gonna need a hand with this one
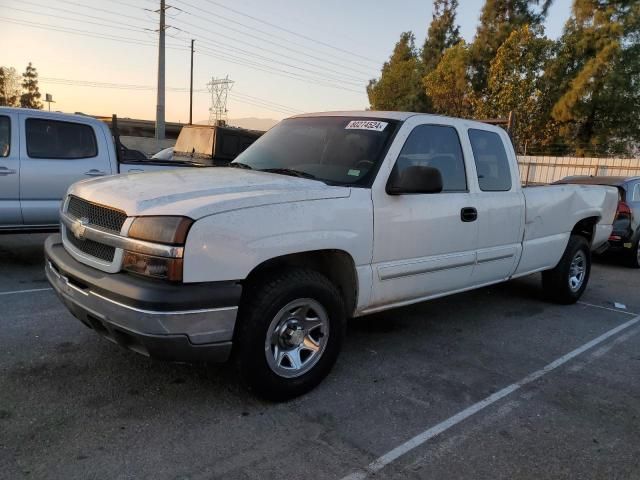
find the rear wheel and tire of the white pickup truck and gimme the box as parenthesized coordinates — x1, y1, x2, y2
(542, 235, 591, 305)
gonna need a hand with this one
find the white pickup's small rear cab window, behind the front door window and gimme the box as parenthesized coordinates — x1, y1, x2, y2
(469, 129, 511, 192)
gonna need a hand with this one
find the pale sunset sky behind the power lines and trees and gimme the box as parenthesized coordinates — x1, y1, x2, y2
(0, 0, 571, 122)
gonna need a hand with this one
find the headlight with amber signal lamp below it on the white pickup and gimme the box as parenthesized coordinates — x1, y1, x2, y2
(122, 217, 193, 282)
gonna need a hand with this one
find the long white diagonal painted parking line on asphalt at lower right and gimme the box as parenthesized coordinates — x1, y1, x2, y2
(342, 316, 640, 480)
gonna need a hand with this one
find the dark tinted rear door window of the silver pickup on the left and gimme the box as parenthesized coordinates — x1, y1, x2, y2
(26, 118, 98, 160)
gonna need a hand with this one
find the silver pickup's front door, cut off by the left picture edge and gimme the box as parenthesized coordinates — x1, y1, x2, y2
(0, 113, 22, 228)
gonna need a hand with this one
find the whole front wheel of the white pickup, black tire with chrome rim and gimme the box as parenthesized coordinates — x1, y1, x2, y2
(234, 269, 346, 401)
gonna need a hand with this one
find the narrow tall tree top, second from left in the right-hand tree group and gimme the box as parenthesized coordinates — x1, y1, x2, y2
(420, 0, 460, 75)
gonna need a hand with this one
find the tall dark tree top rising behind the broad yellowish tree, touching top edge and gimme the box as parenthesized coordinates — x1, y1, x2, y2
(470, 0, 553, 94)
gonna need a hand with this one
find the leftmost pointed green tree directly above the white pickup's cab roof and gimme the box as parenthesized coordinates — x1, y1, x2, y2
(367, 32, 427, 112)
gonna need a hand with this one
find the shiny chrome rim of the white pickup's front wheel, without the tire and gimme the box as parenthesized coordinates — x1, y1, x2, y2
(264, 298, 329, 378)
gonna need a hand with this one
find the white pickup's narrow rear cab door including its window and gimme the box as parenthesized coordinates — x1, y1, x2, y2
(467, 128, 525, 285)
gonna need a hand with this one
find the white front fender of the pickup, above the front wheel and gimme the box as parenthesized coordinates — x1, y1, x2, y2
(184, 189, 373, 283)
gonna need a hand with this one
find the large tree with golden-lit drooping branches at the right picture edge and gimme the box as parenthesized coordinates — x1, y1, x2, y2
(549, 0, 640, 155)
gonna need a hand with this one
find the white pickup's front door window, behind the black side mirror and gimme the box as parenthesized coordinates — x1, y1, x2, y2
(395, 125, 467, 192)
